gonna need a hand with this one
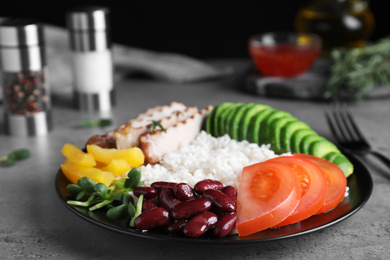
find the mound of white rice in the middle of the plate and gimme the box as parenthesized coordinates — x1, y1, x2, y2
(141, 131, 286, 188)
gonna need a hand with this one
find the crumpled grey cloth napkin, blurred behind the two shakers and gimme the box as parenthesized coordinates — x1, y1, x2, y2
(44, 25, 232, 95)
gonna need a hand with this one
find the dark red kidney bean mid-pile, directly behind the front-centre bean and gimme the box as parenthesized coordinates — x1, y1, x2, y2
(170, 198, 211, 219)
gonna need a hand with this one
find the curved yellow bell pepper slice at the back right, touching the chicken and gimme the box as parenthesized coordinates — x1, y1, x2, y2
(87, 144, 145, 168)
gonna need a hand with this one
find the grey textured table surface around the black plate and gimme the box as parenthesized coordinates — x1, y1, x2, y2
(0, 60, 390, 259)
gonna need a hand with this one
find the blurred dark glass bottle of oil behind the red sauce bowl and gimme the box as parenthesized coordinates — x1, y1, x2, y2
(295, 0, 375, 57)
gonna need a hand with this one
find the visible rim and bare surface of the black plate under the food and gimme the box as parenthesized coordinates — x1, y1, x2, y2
(55, 151, 373, 245)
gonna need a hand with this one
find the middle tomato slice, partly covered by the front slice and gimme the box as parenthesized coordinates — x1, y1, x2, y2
(271, 156, 328, 227)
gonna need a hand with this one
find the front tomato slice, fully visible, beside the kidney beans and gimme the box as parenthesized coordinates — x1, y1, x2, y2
(236, 161, 301, 236)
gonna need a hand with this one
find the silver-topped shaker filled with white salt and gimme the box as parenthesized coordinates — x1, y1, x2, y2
(67, 6, 115, 112)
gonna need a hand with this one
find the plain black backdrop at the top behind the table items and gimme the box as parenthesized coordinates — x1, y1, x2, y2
(0, 0, 390, 58)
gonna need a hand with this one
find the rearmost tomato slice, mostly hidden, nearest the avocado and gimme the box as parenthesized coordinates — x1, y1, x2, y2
(293, 154, 347, 214)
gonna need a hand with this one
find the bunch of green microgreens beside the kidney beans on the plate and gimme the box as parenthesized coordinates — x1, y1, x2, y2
(66, 168, 143, 222)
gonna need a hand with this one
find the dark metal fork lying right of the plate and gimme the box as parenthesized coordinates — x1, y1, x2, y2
(326, 104, 390, 168)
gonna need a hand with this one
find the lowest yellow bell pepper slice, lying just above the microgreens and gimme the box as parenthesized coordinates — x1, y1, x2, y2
(61, 159, 115, 187)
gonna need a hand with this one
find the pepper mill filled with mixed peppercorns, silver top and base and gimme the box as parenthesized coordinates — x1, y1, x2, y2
(0, 18, 52, 136)
